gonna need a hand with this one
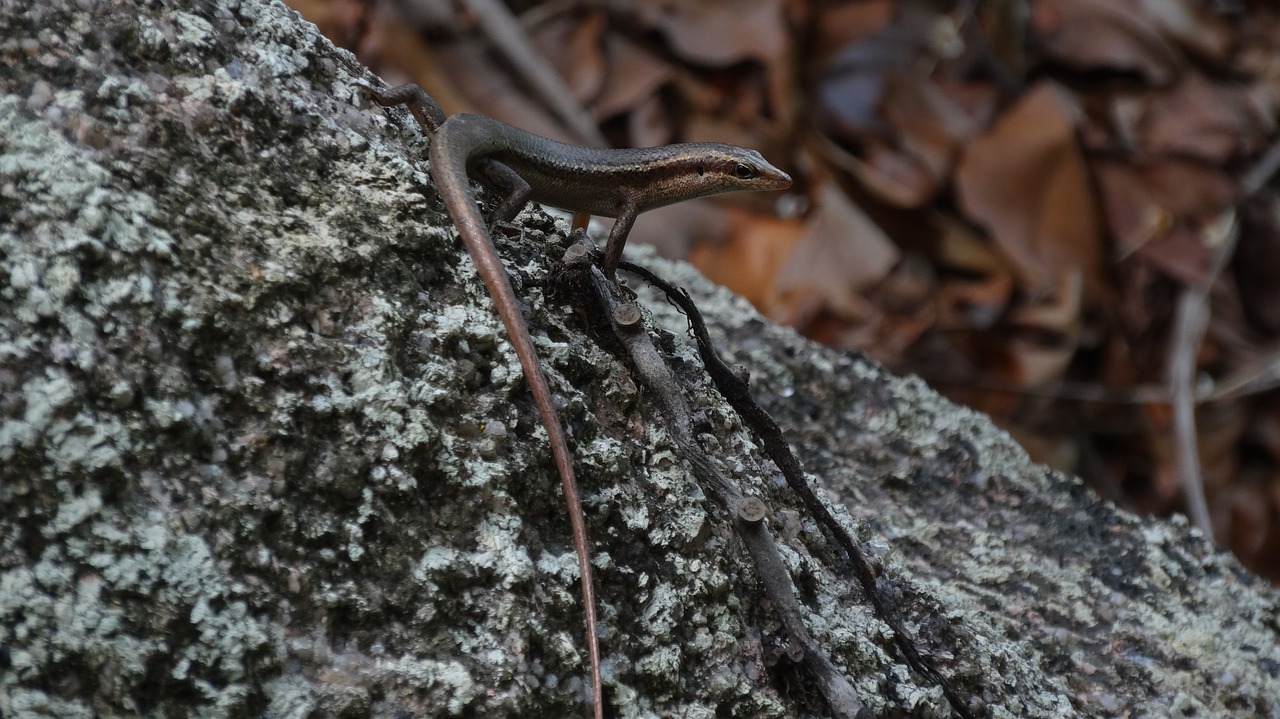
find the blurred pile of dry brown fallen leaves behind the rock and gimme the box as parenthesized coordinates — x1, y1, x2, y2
(291, 0, 1280, 580)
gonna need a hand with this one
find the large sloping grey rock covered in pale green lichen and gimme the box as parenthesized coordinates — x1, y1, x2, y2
(0, 0, 1280, 718)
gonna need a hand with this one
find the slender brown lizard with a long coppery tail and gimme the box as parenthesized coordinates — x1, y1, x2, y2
(358, 83, 791, 719)
